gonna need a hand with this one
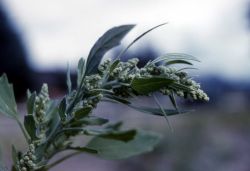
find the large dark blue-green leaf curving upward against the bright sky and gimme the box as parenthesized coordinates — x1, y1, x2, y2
(86, 25, 135, 75)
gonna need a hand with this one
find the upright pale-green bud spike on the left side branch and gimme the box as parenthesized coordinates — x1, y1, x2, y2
(35, 84, 49, 123)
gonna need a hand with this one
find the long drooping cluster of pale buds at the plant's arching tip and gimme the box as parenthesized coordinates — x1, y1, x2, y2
(97, 58, 209, 101)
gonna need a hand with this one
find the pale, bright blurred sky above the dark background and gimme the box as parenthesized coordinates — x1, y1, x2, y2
(1, 0, 250, 79)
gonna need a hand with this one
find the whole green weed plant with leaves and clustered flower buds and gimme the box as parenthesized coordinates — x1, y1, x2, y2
(0, 25, 209, 171)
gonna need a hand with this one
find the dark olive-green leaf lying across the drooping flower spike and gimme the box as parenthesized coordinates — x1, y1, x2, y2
(131, 77, 174, 95)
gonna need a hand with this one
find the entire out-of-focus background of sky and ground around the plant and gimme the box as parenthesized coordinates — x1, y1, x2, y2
(0, 0, 250, 171)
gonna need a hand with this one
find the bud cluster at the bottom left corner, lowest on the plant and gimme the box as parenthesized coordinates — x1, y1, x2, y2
(17, 144, 36, 171)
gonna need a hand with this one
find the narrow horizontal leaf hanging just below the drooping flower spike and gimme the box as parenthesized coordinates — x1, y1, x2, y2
(129, 105, 191, 116)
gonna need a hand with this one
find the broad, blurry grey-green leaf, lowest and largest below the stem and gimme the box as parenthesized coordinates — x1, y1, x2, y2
(86, 131, 160, 160)
